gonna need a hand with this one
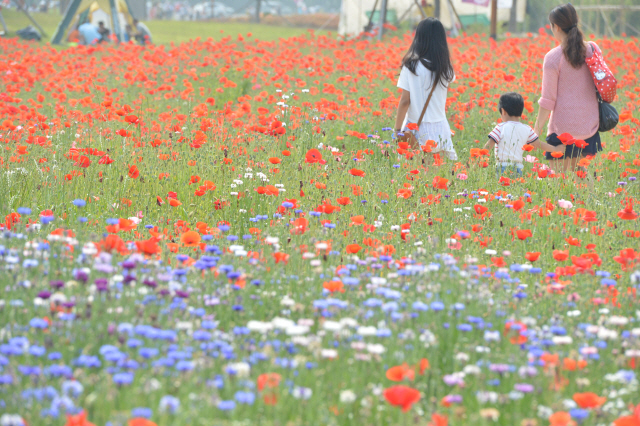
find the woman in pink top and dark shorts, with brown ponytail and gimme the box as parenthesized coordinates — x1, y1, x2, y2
(534, 3, 602, 171)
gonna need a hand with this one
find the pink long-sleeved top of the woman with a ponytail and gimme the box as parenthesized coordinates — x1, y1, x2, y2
(538, 43, 600, 139)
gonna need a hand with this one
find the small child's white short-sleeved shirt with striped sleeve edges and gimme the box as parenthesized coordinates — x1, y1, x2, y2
(489, 121, 538, 165)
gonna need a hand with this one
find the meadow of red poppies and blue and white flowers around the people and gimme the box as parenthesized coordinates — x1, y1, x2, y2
(0, 32, 640, 426)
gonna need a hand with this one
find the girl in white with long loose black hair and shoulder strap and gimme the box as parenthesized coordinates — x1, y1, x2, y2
(394, 18, 458, 160)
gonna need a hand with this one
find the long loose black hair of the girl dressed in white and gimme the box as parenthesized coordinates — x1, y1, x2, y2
(402, 18, 454, 86)
